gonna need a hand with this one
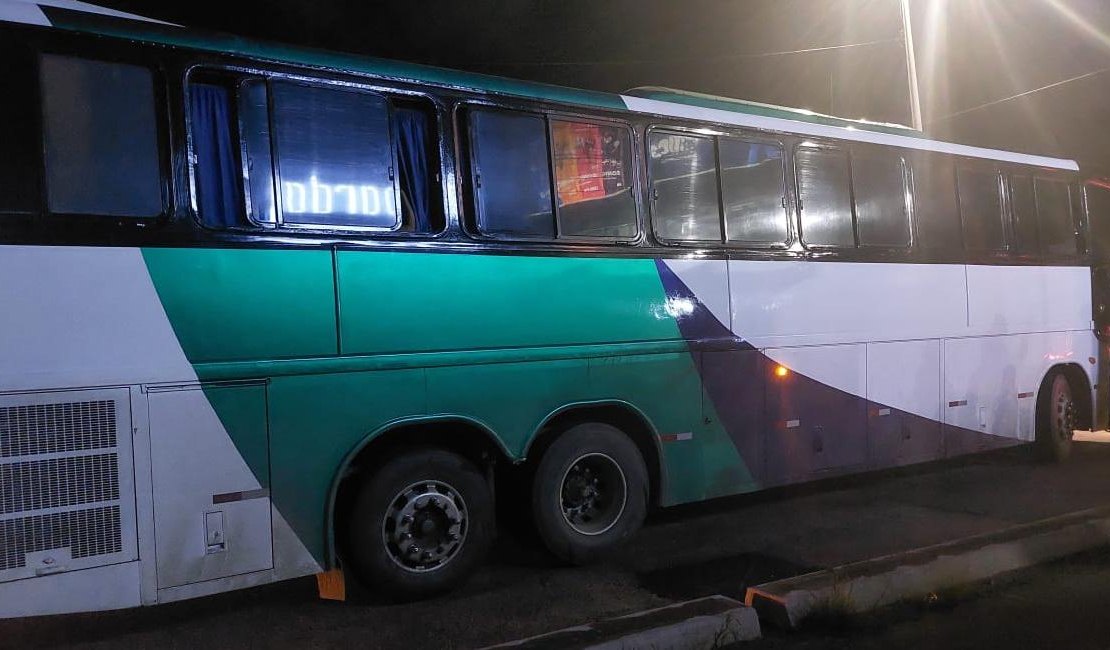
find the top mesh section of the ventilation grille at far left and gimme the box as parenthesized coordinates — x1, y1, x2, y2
(0, 399, 115, 458)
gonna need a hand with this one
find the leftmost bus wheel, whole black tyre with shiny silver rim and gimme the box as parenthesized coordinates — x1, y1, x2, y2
(346, 449, 493, 600)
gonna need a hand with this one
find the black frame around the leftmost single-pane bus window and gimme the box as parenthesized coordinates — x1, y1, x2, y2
(38, 49, 173, 224)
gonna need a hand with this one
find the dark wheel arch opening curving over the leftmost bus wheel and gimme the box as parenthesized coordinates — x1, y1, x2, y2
(324, 415, 517, 568)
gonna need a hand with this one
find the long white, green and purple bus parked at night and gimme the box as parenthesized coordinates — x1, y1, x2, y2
(0, 0, 1110, 617)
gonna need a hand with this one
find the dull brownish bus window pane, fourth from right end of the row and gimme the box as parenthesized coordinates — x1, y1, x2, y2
(911, 156, 963, 251)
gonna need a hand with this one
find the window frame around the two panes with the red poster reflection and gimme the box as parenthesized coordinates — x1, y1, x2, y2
(466, 100, 644, 246)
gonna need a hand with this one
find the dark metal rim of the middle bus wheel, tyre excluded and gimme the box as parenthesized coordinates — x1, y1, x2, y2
(559, 454, 628, 535)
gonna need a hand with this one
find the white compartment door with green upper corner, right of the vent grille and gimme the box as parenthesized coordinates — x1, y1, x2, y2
(149, 384, 273, 589)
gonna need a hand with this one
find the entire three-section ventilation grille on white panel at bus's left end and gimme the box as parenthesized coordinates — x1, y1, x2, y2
(0, 389, 134, 580)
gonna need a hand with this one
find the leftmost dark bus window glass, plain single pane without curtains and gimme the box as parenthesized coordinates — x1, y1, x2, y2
(41, 54, 162, 216)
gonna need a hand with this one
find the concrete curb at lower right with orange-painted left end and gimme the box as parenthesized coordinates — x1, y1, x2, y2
(744, 508, 1110, 628)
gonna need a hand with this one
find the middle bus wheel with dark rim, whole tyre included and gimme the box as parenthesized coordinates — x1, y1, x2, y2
(532, 423, 648, 565)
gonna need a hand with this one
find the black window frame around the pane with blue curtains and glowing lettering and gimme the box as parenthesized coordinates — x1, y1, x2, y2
(181, 62, 452, 235)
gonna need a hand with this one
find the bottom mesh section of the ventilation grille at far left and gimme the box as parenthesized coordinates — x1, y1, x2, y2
(0, 506, 122, 571)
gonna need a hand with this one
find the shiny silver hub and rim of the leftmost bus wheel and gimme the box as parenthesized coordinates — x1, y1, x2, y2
(382, 480, 467, 572)
